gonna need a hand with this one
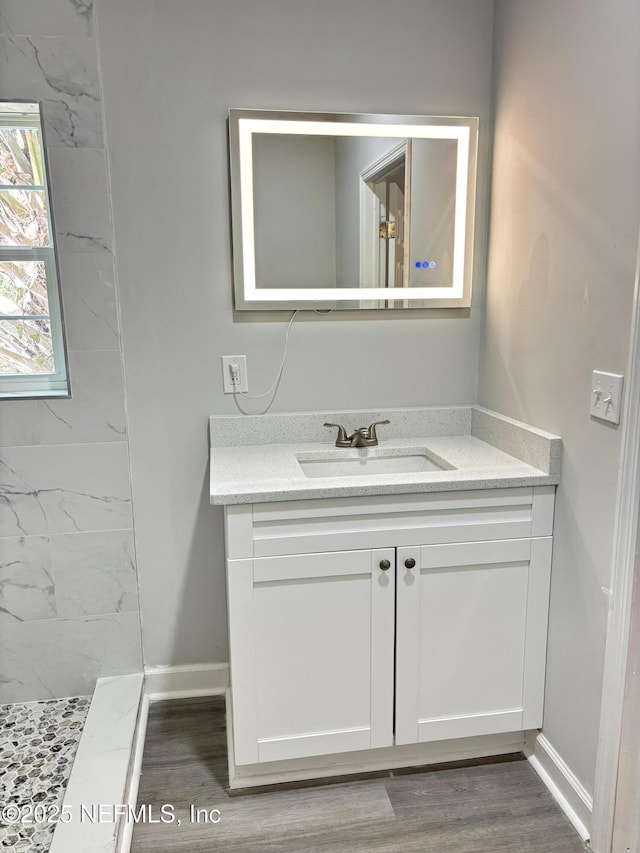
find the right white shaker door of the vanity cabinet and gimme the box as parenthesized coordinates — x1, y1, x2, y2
(396, 537, 551, 744)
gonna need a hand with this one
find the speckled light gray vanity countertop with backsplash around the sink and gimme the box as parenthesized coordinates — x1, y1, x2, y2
(210, 406, 561, 504)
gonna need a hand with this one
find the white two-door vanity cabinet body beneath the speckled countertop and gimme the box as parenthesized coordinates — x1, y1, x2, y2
(225, 486, 555, 766)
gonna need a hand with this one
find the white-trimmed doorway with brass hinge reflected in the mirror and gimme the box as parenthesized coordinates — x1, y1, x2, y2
(360, 140, 411, 307)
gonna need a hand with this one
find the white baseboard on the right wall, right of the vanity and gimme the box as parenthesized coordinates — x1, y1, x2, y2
(525, 732, 593, 841)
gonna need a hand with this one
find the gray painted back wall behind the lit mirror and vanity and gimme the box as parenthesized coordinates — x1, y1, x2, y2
(96, 0, 493, 665)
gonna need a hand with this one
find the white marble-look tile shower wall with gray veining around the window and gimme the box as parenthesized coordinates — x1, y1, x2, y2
(0, 0, 142, 702)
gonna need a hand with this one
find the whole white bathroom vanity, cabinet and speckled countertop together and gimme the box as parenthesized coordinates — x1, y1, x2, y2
(210, 407, 560, 787)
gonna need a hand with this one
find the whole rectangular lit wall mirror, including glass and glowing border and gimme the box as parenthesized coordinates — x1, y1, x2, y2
(229, 109, 478, 310)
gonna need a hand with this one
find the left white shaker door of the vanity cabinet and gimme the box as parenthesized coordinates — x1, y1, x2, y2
(228, 549, 395, 764)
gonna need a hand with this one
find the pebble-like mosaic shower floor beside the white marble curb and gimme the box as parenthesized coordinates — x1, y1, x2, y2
(0, 696, 91, 853)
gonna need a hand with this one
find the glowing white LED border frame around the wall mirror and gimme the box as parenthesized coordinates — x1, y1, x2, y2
(229, 109, 478, 311)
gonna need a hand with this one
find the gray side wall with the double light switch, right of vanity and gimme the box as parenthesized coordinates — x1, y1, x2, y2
(479, 0, 640, 790)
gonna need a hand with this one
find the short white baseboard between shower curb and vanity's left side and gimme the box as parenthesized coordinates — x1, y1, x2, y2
(144, 663, 229, 702)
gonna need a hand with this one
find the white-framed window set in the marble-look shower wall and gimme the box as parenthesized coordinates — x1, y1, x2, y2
(0, 101, 69, 399)
